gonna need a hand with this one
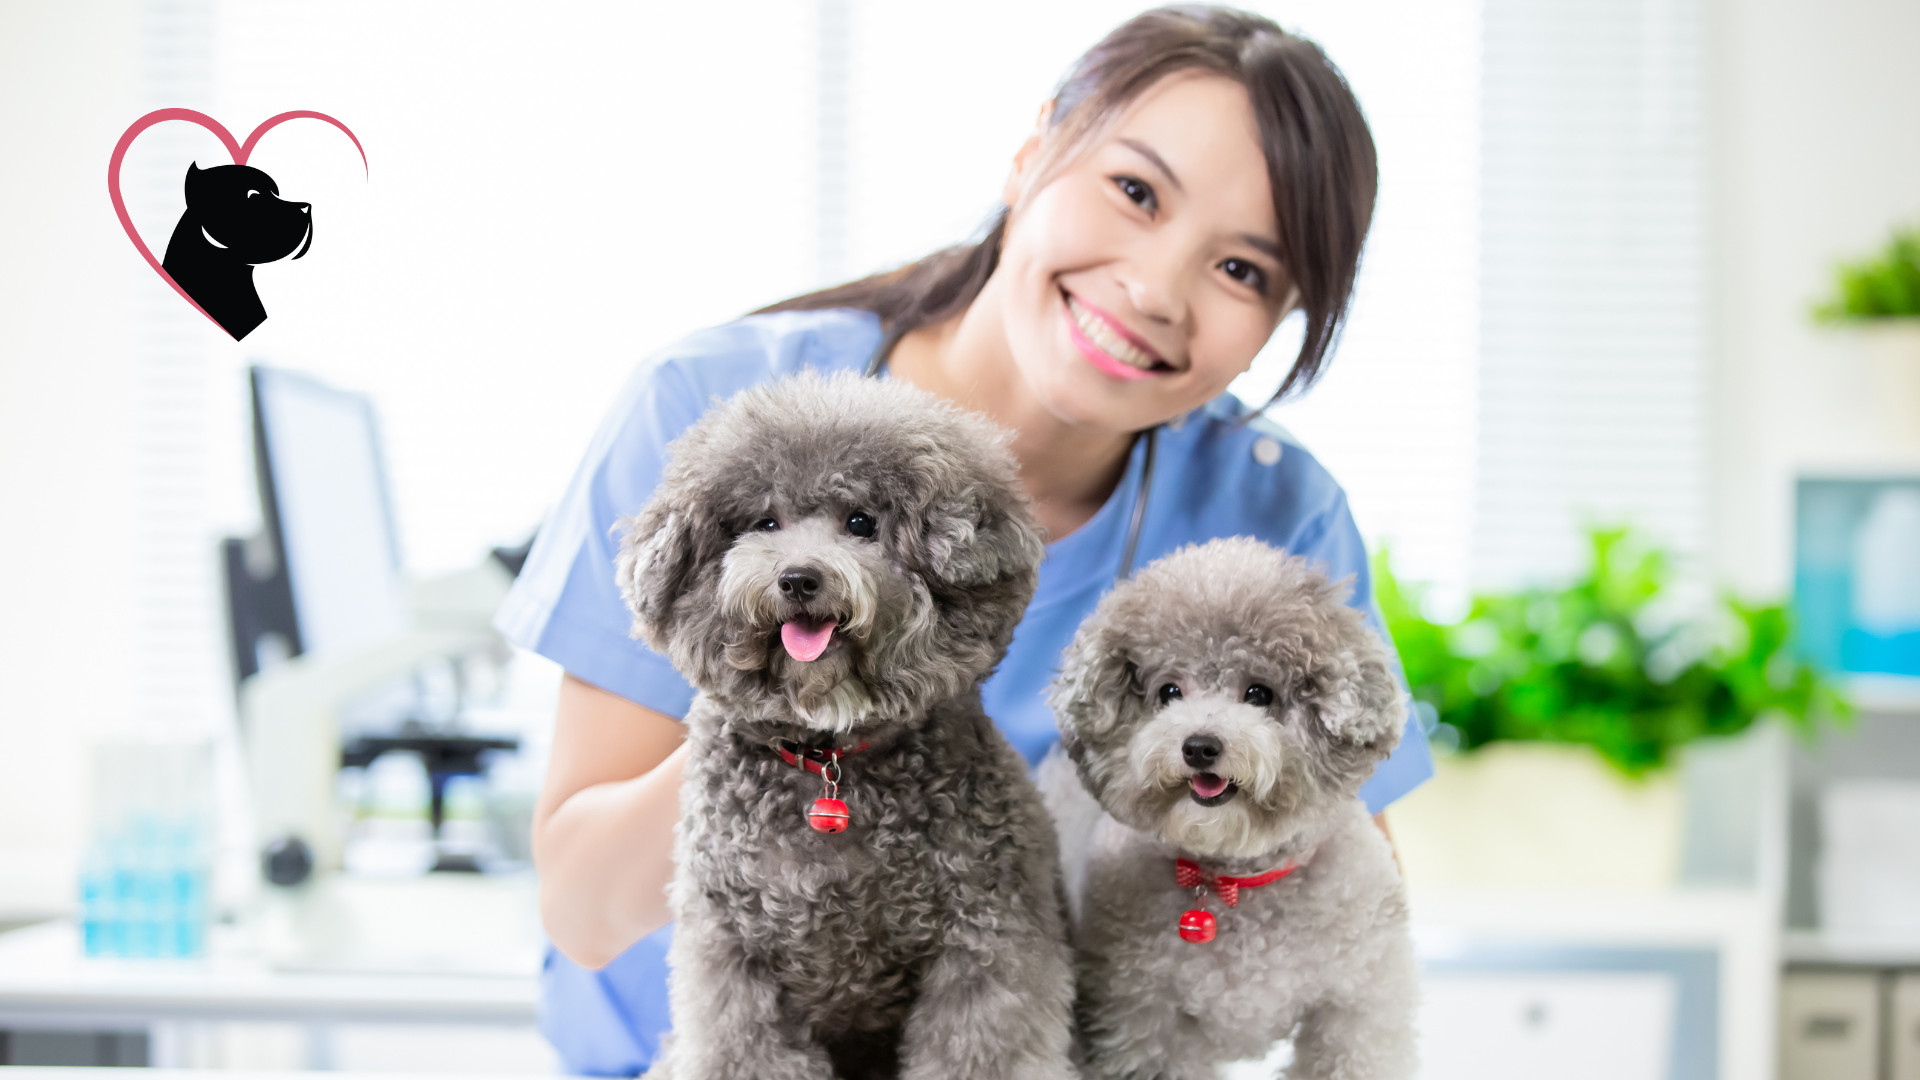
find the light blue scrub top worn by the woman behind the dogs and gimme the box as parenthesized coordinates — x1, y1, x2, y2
(495, 309, 1432, 1076)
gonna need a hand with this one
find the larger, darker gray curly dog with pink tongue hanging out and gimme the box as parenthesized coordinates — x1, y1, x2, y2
(618, 375, 1073, 1080)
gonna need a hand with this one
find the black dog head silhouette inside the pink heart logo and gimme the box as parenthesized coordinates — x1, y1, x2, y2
(161, 163, 313, 340)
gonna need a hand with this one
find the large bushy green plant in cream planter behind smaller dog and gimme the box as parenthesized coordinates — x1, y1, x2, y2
(1375, 528, 1851, 888)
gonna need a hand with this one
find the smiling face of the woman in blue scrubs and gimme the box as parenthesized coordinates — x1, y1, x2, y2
(993, 73, 1292, 430)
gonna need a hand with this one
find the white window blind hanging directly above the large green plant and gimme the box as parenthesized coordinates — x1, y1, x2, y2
(1473, 0, 1709, 584)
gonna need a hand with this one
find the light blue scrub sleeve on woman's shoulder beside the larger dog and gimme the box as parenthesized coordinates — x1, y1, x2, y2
(493, 357, 707, 717)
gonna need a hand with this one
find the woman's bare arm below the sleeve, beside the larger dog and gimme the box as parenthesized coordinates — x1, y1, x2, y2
(534, 675, 685, 969)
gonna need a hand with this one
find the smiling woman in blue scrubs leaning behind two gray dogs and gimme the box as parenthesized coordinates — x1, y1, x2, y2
(499, 8, 1432, 1074)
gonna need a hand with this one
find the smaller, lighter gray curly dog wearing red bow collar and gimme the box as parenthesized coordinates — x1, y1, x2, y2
(1050, 538, 1419, 1080)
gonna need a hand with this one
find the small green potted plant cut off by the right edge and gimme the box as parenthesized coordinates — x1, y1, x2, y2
(1812, 225, 1920, 440)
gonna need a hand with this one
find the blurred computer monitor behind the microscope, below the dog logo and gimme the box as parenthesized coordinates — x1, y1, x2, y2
(227, 365, 407, 680)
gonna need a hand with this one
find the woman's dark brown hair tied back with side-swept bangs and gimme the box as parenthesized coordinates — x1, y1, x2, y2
(756, 4, 1379, 400)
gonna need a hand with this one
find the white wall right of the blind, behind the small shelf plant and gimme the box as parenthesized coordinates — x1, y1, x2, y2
(1713, 0, 1920, 596)
